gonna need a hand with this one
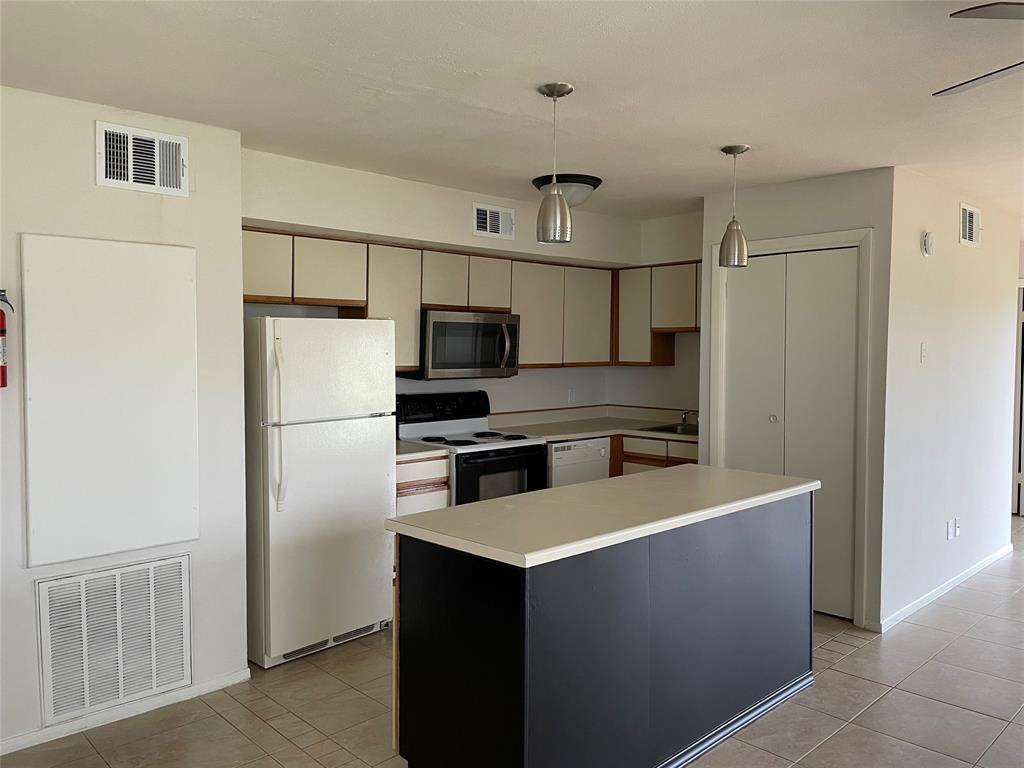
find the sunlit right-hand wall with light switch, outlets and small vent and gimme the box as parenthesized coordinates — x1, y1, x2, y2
(882, 168, 1020, 616)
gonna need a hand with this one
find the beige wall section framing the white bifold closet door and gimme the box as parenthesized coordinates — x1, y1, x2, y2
(700, 168, 893, 623)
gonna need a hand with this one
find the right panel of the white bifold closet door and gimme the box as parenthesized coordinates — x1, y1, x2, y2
(786, 248, 857, 617)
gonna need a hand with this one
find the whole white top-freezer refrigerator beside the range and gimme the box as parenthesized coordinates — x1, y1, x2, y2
(245, 317, 395, 668)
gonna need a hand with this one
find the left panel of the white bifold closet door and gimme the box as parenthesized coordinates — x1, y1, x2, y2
(724, 254, 786, 474)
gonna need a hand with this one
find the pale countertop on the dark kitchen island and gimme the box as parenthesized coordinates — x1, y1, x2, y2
(384, 464, 821, 568)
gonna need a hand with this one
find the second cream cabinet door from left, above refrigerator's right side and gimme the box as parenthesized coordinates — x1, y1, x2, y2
(295, 238, 367, 306)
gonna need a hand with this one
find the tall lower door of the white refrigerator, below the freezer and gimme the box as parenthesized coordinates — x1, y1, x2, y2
(263, 416, 395, 656)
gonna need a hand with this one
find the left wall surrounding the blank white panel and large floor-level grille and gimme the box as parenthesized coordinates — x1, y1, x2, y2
(0, 88, 247, 749)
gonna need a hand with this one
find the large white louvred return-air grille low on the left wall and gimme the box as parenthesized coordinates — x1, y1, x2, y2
(37, 555, 191, 725)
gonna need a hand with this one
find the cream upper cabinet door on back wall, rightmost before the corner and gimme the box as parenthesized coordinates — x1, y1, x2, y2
(562, 266, 611, 366)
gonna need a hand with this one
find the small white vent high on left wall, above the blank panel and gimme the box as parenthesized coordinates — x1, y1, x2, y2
(96, 122, 188, 198)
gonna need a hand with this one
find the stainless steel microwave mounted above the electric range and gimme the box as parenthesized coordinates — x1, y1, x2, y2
(409, 309, 519, 379)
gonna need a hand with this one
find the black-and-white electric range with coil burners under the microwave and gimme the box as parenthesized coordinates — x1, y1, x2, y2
(396, 390, 548, 504)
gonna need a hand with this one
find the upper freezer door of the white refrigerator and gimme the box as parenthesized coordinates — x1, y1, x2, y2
(262, 317, 394, 424)
